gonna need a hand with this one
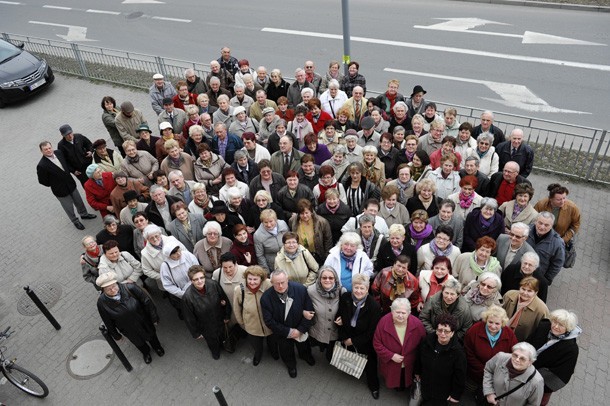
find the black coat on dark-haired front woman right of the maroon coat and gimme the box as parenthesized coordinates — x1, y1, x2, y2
(415, 333, 466, 406)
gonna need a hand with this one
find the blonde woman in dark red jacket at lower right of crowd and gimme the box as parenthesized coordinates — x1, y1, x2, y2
(464, 304, 517, 398)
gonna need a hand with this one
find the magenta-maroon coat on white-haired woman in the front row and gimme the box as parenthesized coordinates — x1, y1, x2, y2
(373, 313, 426, 388)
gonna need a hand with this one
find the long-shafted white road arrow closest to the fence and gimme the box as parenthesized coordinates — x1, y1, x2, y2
(384, 68, 591, 114)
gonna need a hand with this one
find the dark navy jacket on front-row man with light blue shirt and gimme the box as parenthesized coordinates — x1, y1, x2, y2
(261, 282, 313, 338)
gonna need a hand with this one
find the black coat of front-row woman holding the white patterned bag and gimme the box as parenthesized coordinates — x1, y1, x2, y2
(335, 292, 381, 354)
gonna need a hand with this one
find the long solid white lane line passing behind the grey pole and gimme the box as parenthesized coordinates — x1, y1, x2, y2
(261, 27, 610, 72)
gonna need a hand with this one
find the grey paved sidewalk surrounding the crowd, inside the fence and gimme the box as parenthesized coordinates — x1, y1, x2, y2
(0, 75, 610, 406)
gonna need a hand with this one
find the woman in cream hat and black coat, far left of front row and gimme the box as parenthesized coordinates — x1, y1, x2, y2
(96, 272, 165, 364)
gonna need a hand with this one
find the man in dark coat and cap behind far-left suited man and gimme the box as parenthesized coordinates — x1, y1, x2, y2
(57, 124, 93, 185)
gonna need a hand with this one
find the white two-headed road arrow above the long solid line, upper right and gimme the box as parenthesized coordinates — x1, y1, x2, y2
(413, 18, 606, 46)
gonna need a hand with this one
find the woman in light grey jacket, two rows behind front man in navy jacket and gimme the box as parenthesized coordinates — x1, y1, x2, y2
(254, 209, 289, 272)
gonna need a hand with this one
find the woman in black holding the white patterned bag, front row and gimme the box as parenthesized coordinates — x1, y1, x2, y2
(331, 274, 381, 399)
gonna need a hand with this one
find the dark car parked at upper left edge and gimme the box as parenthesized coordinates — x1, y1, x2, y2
(0, 40, 55, 107)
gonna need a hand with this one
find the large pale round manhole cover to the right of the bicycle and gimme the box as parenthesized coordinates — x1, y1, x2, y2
(66, 337, 114, 379)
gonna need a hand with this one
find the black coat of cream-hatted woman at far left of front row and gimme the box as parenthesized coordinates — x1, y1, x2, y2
(97, 283, 159, 347)
